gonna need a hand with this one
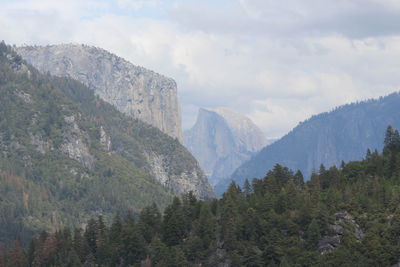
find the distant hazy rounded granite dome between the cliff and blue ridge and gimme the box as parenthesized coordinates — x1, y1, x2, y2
(184, 108, 266, 184)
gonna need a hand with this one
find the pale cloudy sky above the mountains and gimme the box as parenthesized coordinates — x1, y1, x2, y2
(0, 0, 400, 138)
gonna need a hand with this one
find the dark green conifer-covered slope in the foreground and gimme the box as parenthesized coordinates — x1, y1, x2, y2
(0, 127, 400, 267)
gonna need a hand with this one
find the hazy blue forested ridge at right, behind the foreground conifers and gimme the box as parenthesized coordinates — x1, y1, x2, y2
(216, 93, 400, 193)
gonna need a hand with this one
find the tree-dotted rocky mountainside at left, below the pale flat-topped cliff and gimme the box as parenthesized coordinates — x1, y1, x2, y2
(0, 43, 214, 243)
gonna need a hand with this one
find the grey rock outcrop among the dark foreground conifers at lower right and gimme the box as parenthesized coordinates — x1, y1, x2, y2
(318, 214, 364, 254)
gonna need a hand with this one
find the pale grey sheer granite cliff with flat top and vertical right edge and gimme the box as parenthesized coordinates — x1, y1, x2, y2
(16, 44, 183, 142)
